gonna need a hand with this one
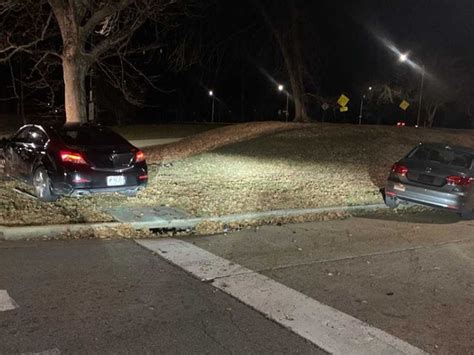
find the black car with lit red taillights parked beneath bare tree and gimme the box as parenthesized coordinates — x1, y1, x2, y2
(0, 123, 148, 201)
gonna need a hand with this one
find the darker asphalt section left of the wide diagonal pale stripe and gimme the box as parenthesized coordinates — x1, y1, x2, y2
(0, 240, 321, 354)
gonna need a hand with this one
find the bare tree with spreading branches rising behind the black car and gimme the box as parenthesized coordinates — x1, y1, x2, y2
(0, 0, 191, 122)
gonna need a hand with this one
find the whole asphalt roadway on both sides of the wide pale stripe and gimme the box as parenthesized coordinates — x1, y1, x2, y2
(0, 212, 474, 354)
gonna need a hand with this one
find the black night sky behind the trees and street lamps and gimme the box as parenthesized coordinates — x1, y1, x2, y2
(0, 0, 474, 128)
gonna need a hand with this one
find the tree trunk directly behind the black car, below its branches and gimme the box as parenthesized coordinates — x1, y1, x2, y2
(63, 56, 87, 123)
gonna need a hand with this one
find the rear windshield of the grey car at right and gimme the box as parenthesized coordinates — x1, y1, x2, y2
(408, 146, 473, 169)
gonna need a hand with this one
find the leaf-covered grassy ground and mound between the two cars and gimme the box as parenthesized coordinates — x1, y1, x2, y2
(0, 124, 474, 225)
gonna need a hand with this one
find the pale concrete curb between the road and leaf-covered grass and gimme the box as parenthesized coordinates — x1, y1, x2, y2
(0, 204, 387, 240)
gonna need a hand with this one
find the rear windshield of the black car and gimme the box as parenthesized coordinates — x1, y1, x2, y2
(58, 126, 128, 146)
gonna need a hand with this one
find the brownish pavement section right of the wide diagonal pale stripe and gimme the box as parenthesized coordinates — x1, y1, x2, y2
(191, 212, 474, 354)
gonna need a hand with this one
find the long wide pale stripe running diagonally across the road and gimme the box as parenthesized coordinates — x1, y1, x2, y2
(136, 238, 425, 354)
